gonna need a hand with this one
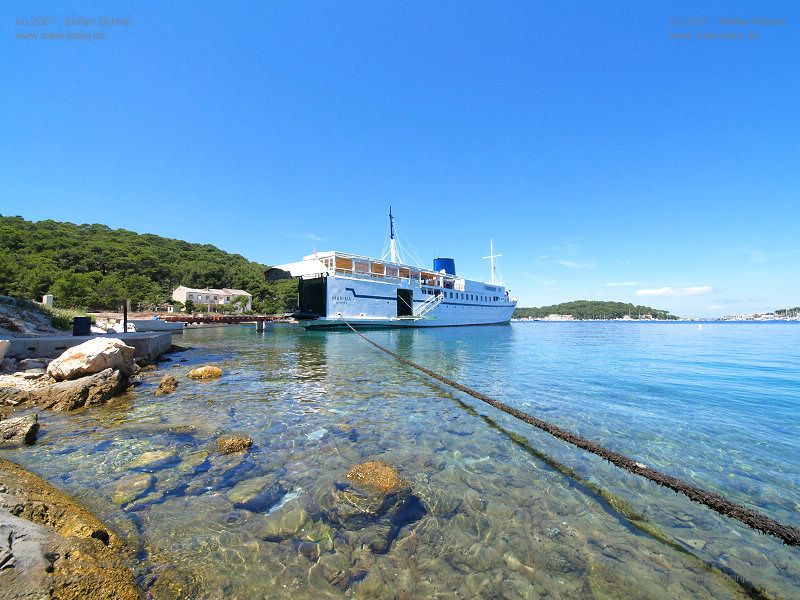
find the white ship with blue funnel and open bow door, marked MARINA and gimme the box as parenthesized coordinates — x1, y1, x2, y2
(265, 209, 517, 329)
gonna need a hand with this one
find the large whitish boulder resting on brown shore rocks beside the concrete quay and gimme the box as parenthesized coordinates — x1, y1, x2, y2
(47, 337, 136, 381)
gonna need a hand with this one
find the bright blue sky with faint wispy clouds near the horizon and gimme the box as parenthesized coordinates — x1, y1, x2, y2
(0, 1, 800, 316)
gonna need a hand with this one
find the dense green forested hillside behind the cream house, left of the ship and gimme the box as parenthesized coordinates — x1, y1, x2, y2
(0, 215, 297, 313)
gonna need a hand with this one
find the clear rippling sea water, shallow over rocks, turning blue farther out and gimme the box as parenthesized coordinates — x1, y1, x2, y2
(7, 323, 800, 598)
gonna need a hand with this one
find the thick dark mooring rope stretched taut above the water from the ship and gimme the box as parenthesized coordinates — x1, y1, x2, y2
(340, 317, 800, 546)
